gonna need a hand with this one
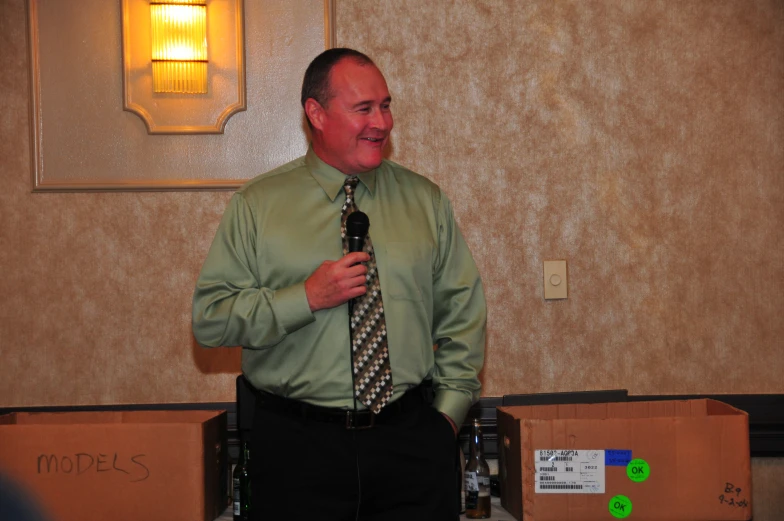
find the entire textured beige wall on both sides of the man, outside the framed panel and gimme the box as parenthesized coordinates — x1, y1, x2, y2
(0, 0, 784, 406)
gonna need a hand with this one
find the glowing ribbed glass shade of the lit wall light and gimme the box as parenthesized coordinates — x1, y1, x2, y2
(150, 0, 207, 94)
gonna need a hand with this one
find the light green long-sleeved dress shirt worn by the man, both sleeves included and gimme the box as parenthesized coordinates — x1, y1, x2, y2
(193, 148, 487, 425)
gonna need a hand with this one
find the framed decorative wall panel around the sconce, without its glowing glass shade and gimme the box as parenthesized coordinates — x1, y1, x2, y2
(25, 0, 335, 192)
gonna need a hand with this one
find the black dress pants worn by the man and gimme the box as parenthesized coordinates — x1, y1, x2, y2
(250, 394, 459, 521)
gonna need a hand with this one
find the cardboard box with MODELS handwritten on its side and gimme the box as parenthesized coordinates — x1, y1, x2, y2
(0, 411, 228, 521)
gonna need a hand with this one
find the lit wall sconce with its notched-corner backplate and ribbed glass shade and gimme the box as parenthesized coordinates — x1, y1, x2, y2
(122, 0, 246, 134)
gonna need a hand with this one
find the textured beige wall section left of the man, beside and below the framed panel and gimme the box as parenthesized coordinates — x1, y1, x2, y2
(0, 0, 239, 406)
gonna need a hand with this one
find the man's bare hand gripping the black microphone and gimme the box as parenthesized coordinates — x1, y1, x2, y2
(305, 251, 370, 311)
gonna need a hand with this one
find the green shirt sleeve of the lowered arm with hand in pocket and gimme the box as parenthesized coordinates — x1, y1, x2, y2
(433, 194, 487, 425)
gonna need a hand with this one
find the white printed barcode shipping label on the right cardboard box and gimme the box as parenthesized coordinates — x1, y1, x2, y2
(534, 449, 605, 494)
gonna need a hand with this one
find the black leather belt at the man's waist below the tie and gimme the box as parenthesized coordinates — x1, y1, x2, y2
(255, 382, 429, 430)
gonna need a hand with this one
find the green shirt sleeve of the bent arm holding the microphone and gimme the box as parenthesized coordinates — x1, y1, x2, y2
(192, 193, 315, 348)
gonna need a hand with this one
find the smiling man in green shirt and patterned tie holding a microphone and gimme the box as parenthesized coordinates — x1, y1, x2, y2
(193, 49, 486, 521)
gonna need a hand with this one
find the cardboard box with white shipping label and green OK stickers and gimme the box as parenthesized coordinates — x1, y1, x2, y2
(497, 399, 751, 521)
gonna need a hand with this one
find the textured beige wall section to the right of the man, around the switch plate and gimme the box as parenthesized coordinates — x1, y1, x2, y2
(336, 0, 784, 396)
